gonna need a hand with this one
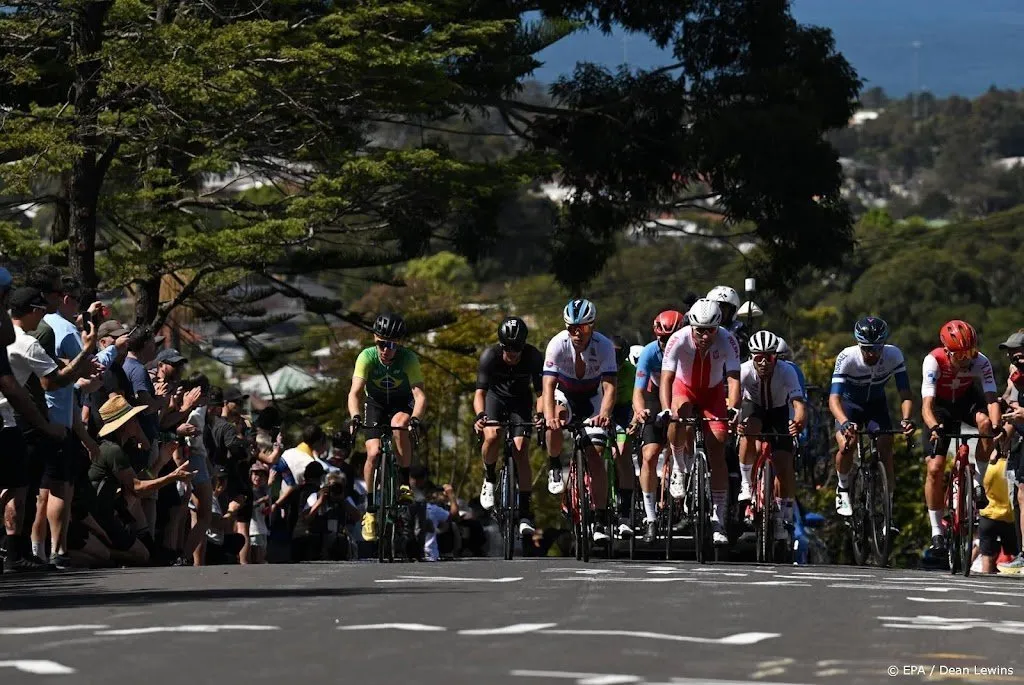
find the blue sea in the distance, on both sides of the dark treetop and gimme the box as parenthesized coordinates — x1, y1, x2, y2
(535, 0, 1024, 97)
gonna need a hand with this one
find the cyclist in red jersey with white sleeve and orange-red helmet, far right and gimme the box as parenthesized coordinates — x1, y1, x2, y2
(921, 319, 1002, 554)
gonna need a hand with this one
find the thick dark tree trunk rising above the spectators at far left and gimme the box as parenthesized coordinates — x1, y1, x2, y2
(68, 2, 112, 302)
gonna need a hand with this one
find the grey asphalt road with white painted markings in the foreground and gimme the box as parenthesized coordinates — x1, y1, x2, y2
(0, 559, 1024, 685)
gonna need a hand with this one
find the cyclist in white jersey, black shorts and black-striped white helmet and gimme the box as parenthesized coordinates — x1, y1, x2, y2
(737, 331, 807, 540)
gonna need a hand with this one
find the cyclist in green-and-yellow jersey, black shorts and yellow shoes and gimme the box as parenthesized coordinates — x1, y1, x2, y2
(348, 313, 427, 542)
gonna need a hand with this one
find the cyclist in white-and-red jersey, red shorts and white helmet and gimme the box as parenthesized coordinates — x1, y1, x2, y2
(658, 300, 740, 545)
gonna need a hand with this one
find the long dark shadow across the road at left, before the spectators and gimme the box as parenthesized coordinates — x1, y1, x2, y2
(0, 572, 458, 611)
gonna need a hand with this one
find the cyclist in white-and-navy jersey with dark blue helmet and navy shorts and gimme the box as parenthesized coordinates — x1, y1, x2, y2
(828, 316, 915, 516)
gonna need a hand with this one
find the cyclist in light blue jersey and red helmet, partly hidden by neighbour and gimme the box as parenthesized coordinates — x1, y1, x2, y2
(633, 309, 686, 544)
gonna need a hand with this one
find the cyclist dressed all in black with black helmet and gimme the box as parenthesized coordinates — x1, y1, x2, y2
(473, 316, 544, 536)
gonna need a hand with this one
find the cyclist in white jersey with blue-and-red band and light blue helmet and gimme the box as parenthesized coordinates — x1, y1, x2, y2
(543, 300, 618, 542)
